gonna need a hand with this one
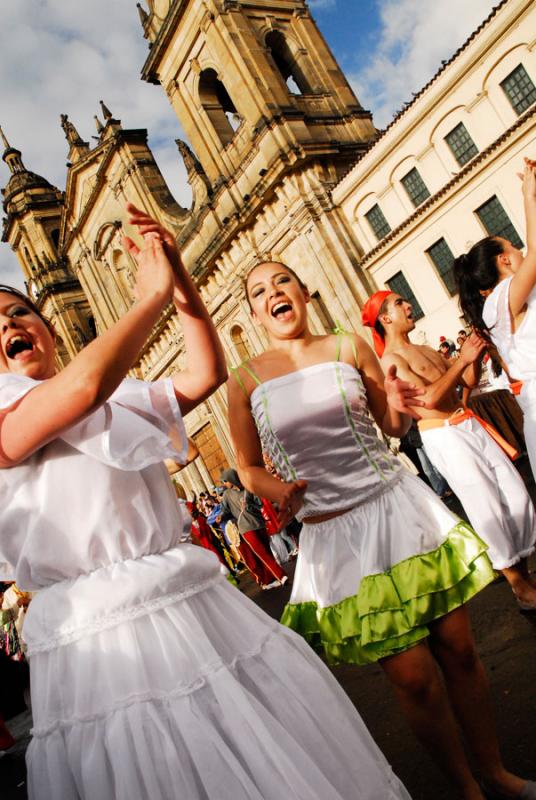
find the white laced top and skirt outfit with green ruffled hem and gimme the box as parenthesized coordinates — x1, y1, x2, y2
(247, 361, 493, 664)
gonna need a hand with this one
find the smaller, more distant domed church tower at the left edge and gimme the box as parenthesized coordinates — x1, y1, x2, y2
(0, 128, 95, 365)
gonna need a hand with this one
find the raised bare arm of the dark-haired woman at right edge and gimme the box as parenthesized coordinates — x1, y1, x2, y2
(509, 159, 536, 318)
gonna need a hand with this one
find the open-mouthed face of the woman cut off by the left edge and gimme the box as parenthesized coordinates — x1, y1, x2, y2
(0, 291, 54, 380)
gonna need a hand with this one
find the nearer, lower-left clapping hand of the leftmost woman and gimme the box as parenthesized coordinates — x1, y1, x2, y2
(123, 234, 174, 305)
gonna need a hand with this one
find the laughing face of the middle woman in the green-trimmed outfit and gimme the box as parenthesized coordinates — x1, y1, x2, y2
(246, 261, 309, 339)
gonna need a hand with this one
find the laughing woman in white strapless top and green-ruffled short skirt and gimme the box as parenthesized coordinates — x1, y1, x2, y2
(228, 262, 536, 800)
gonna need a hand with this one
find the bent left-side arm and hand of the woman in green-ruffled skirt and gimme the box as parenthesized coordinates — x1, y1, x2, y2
(227, 375, 307, 526)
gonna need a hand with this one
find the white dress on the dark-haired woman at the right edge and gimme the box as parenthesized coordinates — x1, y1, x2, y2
(482, 277, 536, 476)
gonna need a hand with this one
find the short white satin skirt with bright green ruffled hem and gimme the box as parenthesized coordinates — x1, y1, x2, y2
(282, 470, 494, 664)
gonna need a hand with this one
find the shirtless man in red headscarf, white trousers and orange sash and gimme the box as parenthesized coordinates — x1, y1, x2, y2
(363, 291, 536, 612)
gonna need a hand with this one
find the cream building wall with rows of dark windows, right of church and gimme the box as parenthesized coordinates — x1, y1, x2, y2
(333, 0, 536, 346)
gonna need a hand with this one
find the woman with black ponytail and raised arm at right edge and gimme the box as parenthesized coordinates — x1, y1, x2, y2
(454, 159, 536, 476)
